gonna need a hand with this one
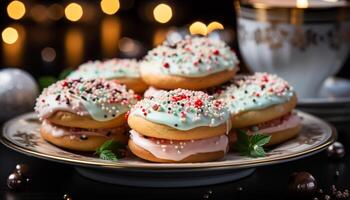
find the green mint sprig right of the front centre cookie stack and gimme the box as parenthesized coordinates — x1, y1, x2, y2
(236, 129, 271, 158)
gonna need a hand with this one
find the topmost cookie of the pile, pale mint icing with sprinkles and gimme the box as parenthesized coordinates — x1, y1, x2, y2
(140, 36, 239, 90)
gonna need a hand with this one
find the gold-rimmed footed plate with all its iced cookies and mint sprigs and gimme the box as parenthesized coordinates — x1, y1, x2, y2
(1, 37, 336, 187)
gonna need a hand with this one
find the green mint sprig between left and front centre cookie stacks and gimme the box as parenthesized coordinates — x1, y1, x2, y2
(95, 140, 125, 161)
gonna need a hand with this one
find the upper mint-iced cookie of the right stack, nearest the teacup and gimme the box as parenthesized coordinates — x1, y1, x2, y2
(220, 73, 297, 127)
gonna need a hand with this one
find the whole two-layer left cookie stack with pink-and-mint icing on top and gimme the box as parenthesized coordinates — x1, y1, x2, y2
(35, 79, 138, 151)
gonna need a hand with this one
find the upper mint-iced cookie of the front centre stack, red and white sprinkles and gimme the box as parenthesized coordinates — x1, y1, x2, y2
(128, 89, 230, 139)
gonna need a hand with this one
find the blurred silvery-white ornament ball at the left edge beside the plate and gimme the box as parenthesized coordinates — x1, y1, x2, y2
(0, 68, 39, 122)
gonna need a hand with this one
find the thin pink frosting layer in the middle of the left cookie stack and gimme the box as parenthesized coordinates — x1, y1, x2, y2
(41, 120, 118, 138)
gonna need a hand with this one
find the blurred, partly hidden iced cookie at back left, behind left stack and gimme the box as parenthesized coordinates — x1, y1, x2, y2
(67, 58, 148, 93)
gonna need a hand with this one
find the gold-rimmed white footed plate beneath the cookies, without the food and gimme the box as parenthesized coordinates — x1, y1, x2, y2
(1, 111, 336, 187)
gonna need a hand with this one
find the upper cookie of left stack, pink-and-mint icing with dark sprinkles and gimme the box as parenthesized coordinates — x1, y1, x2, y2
(35, 79, 139, 128)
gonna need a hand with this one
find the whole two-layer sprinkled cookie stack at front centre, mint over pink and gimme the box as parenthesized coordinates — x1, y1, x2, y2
(128, 89, 230, 162)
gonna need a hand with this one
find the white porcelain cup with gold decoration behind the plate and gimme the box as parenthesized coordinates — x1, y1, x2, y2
(236, 0, 350, 98)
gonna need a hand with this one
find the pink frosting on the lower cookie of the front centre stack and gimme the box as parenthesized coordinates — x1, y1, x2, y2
(130, 130, 228, 161)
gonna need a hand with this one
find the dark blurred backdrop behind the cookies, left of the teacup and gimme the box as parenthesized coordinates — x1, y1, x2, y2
(0, 0, 350, 78)
